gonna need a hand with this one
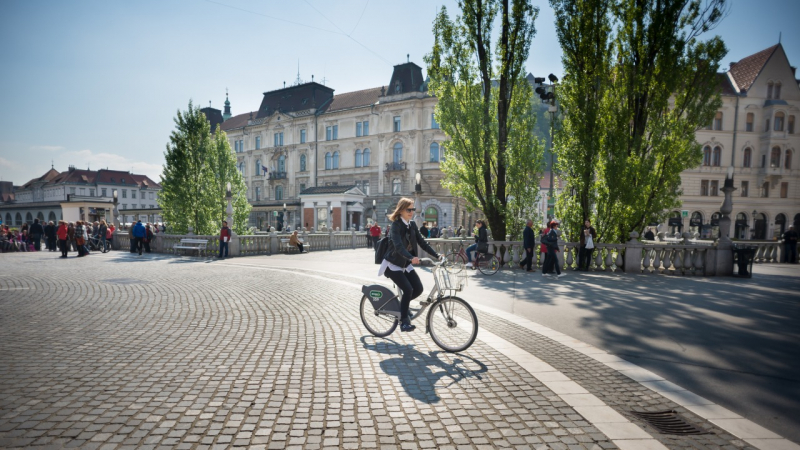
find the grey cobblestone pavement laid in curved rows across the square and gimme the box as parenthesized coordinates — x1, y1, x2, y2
(0, 252, 776, 449)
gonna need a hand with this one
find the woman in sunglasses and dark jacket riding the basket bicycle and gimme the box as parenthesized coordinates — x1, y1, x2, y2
(378, 198, 440, 331)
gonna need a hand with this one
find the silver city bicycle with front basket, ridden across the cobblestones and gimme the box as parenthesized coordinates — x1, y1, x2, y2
(359, 258, 478, 353)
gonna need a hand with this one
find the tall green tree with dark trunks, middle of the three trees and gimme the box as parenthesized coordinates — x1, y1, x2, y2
(425, 0, 542, 240)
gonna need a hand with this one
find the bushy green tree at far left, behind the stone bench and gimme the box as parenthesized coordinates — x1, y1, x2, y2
(158, 101, 250, 235)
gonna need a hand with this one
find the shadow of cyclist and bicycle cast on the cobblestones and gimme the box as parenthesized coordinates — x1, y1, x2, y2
(360, 335, 489, 404)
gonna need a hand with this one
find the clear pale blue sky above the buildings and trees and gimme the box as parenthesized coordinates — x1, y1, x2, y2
(0, 0, 800, 184)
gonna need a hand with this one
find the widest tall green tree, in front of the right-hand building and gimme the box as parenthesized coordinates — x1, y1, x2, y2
(551, 0, 727, 242)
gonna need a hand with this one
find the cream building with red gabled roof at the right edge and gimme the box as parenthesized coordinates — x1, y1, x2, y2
(666, 44, 800, 239)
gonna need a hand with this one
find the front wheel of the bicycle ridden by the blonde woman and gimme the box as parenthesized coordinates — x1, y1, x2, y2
(428, 296, 478, 353)
